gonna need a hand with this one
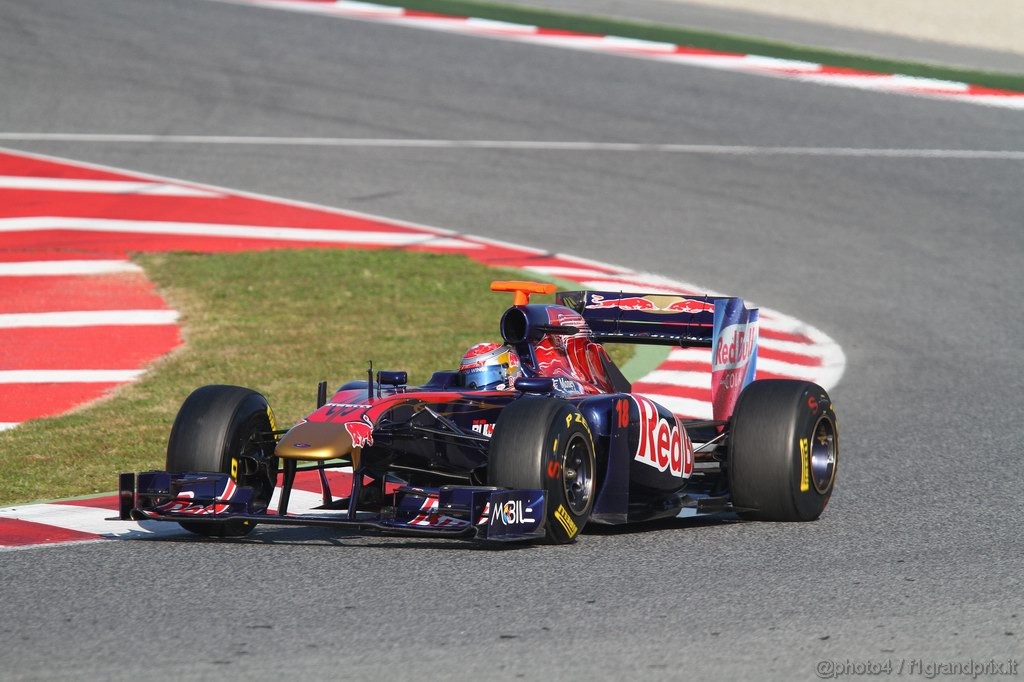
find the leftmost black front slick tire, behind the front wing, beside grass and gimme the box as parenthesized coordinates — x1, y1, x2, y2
(167, 385, 278, 538)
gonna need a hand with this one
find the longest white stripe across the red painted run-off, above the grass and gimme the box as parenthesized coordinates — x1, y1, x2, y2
(0, 216, 480, 251)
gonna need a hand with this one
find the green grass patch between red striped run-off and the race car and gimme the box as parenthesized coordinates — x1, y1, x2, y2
(0, 249, 630, 506)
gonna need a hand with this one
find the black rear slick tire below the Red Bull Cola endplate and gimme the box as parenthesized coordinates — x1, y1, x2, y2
(727, 379, 839, 521)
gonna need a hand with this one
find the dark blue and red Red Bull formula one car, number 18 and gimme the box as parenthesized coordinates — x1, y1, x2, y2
(120, 282, 839, 543)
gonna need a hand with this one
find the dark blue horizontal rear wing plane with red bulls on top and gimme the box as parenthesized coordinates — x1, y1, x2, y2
(555, 291, 746, 348)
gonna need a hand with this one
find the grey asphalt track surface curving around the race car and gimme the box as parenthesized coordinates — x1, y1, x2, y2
(0, 0, 1024, 680)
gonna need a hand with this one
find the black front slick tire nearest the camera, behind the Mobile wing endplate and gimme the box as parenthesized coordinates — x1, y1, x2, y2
(487, 397, 597, 545)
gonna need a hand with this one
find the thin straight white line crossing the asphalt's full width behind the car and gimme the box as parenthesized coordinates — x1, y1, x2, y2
(0, 132, 1024, 161)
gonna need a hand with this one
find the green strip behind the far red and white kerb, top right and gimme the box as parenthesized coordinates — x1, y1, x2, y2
(373, 0, 1024, 92)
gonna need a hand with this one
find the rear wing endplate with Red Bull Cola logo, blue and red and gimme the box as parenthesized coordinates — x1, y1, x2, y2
(711, 299, 758, 419)
